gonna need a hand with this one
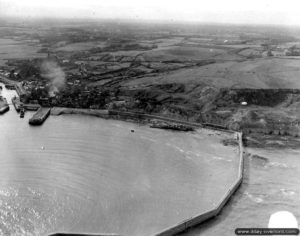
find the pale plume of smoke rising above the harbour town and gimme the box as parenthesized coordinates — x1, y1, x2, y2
(41, 61, 66, 96)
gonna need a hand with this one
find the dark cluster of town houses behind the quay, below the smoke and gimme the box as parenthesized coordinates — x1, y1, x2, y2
(15, 76, 132, 109)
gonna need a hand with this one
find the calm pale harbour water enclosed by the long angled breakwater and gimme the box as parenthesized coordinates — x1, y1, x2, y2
(0, 84, 239, 236)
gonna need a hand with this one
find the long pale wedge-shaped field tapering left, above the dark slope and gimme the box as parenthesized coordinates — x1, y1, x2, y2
(125, 58, 300, 89)
